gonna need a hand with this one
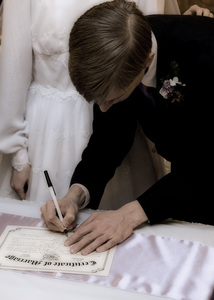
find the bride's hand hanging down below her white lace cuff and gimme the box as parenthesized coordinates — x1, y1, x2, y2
(10, 165, 31, 200)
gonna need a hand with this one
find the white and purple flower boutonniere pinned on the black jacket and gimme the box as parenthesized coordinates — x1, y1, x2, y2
(159, 61, 186, 104)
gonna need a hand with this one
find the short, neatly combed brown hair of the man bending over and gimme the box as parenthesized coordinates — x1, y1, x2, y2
(69, 0, 152, 102)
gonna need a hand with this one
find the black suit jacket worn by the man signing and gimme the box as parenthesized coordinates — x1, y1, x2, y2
(71, 15, 214, 224)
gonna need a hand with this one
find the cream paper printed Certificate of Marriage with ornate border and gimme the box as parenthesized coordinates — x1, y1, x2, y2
(0, 226, 115, 276)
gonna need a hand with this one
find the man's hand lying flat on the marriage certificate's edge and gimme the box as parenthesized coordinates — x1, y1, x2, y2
(65, 201, 148, 255)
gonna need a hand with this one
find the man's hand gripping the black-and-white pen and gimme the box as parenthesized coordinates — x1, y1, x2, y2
(40, 186, 85, 232)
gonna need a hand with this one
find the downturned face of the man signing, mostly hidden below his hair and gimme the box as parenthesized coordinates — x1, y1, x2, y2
(99, 53, 154, 112)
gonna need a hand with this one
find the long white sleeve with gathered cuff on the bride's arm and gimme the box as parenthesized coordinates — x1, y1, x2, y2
(0, 0, 32, 166)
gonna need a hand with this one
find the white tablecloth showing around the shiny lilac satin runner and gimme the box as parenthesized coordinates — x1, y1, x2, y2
(0, 198, 214, 300)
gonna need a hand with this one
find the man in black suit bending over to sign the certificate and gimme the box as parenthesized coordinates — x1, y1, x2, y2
(41, 1, 214, 254)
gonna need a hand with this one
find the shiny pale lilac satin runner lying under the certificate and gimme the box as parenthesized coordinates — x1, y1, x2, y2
(0, 214, 214, 300)
